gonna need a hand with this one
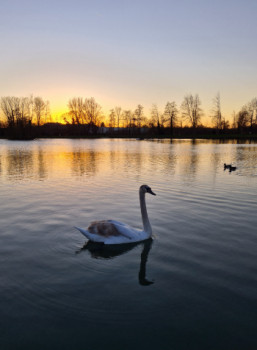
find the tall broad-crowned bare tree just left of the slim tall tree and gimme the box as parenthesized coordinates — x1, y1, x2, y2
(181, 94, 202, 129)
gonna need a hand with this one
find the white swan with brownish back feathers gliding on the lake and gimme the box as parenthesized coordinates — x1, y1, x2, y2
(76, 185, 156, 244)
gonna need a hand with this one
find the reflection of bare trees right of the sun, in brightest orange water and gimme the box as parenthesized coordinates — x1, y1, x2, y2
(72, 150, 97, 176)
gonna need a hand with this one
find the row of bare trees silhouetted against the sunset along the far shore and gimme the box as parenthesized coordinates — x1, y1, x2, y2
(0, 93, 257, 138)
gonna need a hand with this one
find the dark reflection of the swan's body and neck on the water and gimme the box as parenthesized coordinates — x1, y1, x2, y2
(76, 238, 154, 286)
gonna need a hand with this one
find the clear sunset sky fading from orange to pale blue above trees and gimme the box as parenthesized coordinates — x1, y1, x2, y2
(0, 0, 257, 123)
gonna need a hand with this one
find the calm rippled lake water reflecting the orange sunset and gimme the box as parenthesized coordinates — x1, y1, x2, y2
(0, 140, 257, 350)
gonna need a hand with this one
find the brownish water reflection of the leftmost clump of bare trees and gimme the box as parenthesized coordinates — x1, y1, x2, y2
(6, 150, 34, 179)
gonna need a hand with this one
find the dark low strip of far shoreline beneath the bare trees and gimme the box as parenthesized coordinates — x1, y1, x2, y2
(0, 123, 257, 141)
